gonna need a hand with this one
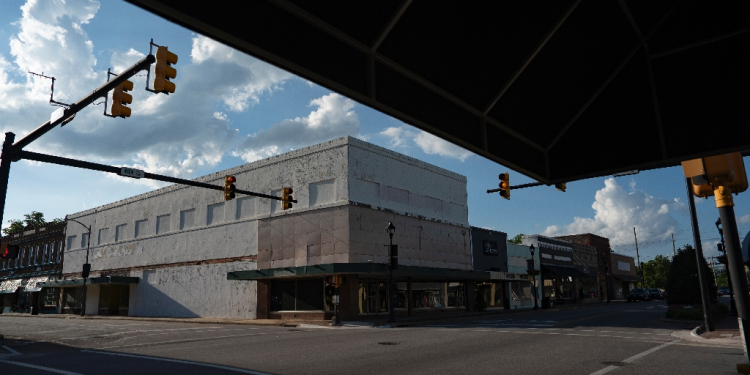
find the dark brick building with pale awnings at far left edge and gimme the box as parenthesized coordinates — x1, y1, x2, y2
(0, 223, 65, 314)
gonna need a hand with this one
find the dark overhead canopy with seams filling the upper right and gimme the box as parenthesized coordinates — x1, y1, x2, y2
(127, 0, 750, 183)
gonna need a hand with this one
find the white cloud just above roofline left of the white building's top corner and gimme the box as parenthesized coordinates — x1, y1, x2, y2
(232, 93, 360, 162)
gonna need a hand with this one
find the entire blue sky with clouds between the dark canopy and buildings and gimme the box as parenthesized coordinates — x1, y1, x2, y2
(0, 0, 750, 260)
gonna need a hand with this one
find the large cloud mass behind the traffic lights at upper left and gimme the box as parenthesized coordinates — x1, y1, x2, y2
(0, 4, 292, 187)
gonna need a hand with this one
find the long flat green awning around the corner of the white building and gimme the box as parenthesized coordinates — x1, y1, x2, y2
(227, 263, 490, 280)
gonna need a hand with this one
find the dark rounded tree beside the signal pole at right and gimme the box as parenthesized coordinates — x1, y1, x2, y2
(667, 245, 717, 305)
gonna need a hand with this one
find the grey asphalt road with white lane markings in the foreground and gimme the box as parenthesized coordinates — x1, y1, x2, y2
(0, 301, 743, 375)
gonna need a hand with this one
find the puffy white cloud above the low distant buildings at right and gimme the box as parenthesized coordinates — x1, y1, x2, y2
(542, 178, 684, 247)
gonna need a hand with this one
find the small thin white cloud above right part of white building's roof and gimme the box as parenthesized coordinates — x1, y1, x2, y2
(379, 125, 473, 161)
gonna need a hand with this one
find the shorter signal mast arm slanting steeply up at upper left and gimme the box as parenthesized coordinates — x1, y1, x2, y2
(11, 55, 156, 153)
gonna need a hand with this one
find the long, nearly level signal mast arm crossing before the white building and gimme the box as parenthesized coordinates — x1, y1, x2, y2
(17, 151, 297, 203)
